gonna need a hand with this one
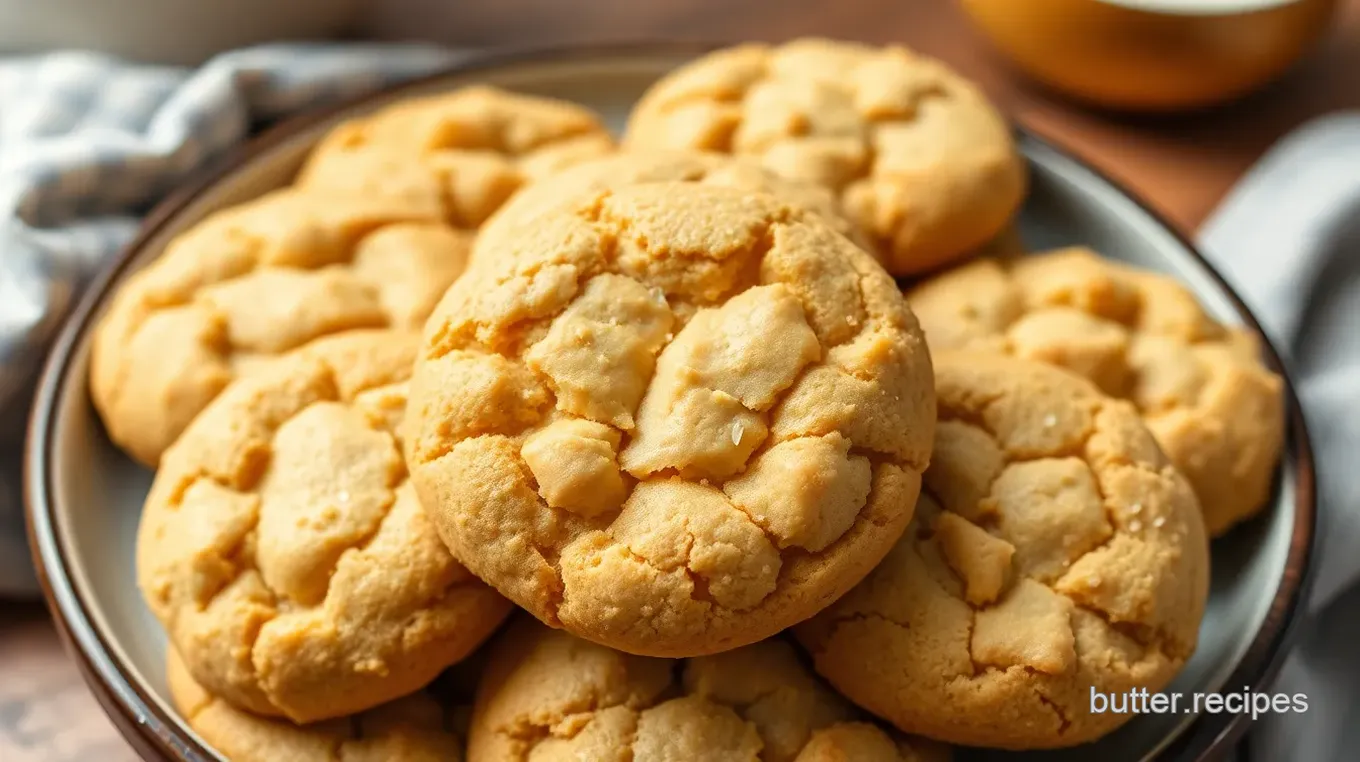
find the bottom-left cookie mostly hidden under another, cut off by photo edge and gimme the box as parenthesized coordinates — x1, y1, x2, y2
(166, 649, 462, 762)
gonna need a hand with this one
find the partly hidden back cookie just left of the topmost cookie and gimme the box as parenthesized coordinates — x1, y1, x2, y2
(296, 86, 613, 230)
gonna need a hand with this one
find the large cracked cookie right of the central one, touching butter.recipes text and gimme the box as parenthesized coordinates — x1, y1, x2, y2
(796, 352, 1209, 750)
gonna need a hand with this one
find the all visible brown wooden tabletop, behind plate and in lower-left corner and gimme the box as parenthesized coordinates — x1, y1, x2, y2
(0, 0, 1360, 762)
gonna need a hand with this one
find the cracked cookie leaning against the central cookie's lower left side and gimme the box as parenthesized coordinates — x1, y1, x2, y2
(136, 331, 510, 723)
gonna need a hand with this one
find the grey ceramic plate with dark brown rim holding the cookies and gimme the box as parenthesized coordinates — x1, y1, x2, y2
(27, 45, 1314, 762)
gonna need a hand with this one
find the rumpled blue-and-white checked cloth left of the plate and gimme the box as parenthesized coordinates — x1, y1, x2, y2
(0, 45, 460, 595)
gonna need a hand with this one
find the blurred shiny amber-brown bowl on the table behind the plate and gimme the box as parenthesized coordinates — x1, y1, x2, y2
(960, 0, 1337, 110)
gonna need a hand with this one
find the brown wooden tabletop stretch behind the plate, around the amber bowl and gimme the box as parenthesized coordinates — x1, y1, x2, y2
(369, 0, 1360, 230)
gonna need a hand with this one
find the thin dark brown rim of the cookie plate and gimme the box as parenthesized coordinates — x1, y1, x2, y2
(23, 41, 1316, 762)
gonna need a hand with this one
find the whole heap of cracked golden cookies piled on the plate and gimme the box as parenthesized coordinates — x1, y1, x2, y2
(91, 41, 1282, 762)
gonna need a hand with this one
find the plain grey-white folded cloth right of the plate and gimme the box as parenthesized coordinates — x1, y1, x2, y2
(1202, 114, 1360, 762)
